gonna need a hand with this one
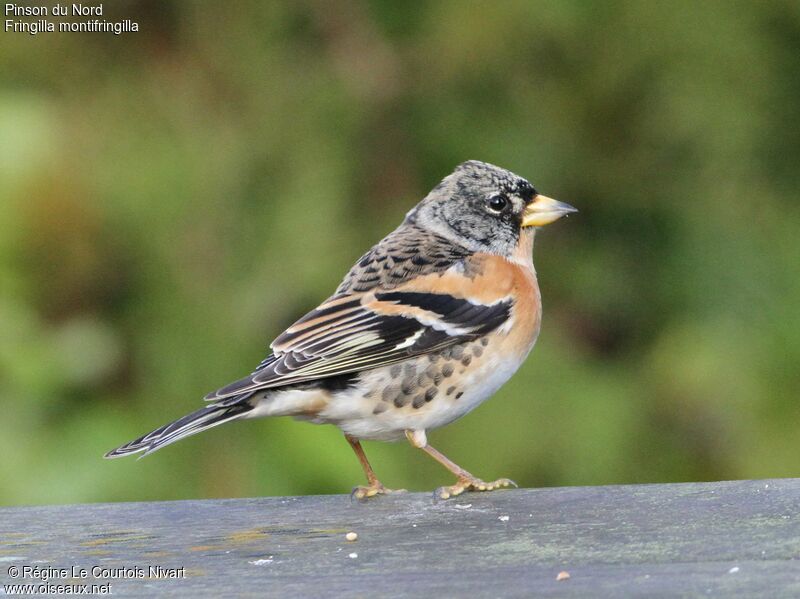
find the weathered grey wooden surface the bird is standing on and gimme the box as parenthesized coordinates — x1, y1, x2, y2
(0, 479, 800, 598)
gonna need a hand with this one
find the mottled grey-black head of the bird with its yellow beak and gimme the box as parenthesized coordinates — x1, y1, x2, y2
(406, 160, 577, 256)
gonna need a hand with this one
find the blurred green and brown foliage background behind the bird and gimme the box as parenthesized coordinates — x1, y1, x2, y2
(0, 0, 800, 504)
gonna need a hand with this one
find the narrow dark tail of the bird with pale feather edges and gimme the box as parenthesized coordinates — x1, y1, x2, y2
(103, 401, 253, 458)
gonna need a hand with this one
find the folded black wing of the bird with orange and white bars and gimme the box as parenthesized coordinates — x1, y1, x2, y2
(206, 272, 513, 401)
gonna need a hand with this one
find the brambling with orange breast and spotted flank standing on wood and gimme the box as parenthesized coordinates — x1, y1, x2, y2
(104, 160, 577, 500)
